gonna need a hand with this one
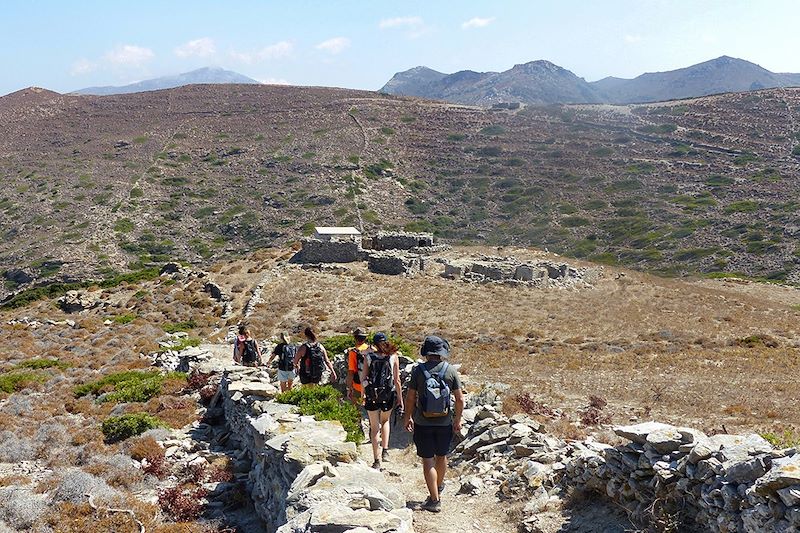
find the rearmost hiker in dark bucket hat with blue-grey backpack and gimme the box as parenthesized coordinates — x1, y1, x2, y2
(403, 335, 464, 513)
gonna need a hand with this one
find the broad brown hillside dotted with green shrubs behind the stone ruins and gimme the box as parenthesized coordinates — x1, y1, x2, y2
(0, 85, 800, 296)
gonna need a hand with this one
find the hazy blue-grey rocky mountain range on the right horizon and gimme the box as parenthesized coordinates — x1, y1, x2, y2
(381, 56, 800, 106)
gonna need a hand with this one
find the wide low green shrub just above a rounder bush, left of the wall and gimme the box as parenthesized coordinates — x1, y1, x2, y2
(73, 370, 186, 403)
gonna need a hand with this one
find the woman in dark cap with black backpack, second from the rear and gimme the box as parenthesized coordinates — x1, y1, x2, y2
(361, 332, 403, 470)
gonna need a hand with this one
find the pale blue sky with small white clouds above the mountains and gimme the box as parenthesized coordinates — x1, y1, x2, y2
(0, 0, 800, 94)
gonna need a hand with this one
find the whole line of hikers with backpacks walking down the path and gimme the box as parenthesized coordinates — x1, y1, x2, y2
(233, 326, 464, 512)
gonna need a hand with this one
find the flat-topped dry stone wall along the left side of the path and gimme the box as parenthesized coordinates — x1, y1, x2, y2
(220, 369, 413, 533)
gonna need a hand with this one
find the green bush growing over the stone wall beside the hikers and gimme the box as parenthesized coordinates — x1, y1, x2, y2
(275, 385, 364, 443)
